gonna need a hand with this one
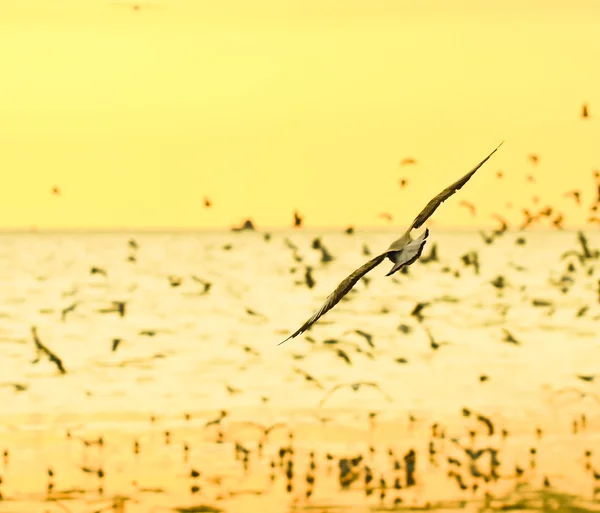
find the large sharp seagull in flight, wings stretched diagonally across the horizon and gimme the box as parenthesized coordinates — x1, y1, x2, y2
(279, 141, 504, 345)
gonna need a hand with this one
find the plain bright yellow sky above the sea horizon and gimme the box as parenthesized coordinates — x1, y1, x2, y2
(0, 0, 600, 229)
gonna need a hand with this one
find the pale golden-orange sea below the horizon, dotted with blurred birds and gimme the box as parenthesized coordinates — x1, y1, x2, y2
(0, 232, 600, 512)
